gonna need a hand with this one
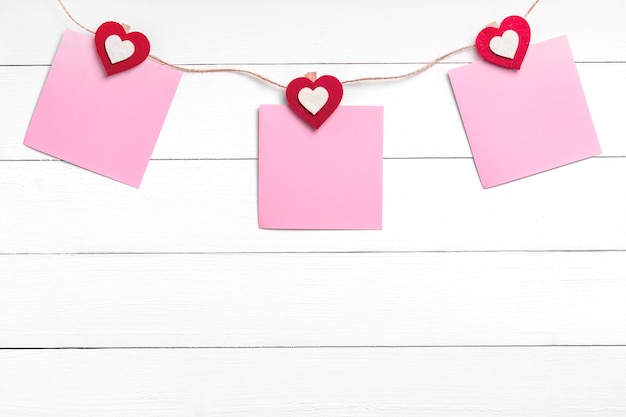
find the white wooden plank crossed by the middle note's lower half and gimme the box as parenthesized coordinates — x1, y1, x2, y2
(0, 158, 626, 253)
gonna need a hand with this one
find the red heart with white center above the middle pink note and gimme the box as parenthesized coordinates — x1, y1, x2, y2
(285, 75, 343, 129)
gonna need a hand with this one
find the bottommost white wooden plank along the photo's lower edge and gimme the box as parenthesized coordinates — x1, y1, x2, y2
(0, 347, 626, 417)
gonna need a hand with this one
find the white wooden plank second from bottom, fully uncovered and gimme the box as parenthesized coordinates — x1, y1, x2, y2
(0, 252, 626, 348)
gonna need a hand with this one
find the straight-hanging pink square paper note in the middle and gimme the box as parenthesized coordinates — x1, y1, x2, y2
(259, 105, 383, 229)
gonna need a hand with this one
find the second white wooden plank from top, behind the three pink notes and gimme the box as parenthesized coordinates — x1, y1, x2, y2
(0, 64, 626, 159)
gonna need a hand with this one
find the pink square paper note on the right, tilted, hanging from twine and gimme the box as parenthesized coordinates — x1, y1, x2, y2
(449, 36, 601, 188)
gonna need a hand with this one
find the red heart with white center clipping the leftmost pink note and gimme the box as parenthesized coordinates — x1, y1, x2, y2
(95, 22, 150, 75)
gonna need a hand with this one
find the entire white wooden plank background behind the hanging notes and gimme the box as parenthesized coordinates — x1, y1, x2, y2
(0, 0, 626, 417)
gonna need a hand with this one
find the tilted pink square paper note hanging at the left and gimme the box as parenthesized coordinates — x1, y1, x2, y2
(24, 30, 181, 187)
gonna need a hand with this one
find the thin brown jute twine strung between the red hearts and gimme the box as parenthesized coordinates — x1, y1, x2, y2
(57, 0, 541, 88)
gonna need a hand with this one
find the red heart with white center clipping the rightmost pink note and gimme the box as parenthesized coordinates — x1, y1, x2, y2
(476, 16, 530, 70)
